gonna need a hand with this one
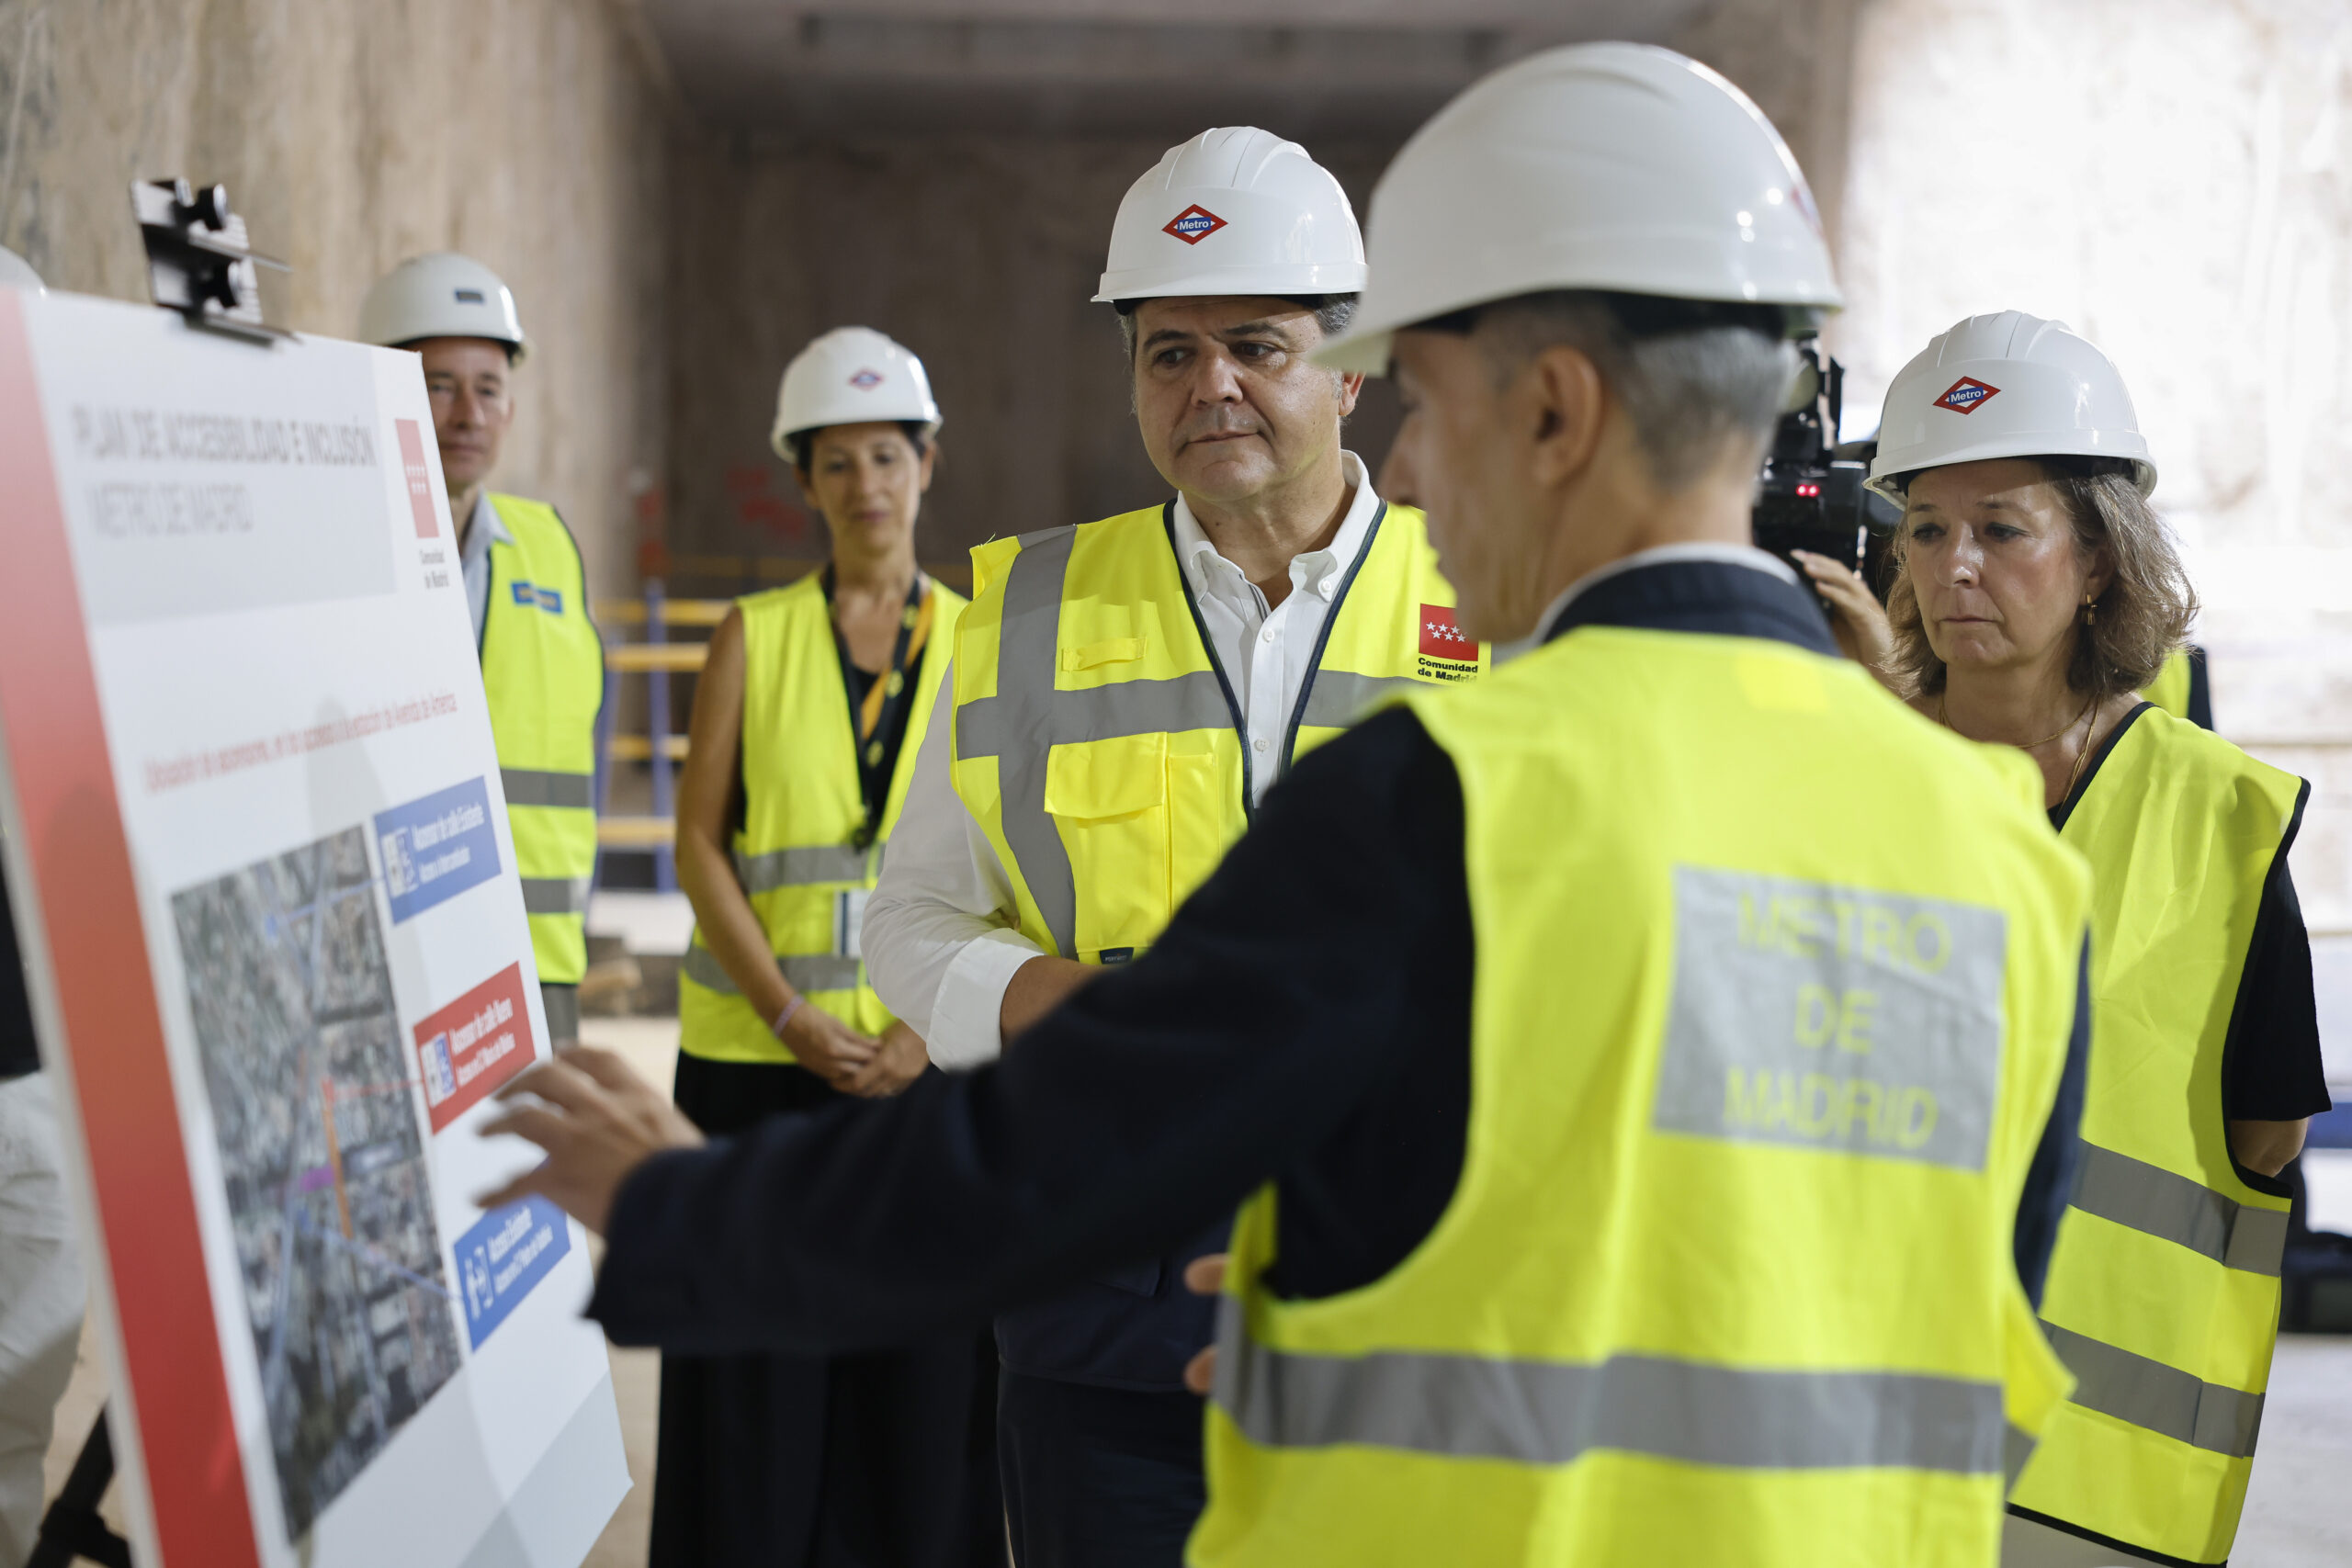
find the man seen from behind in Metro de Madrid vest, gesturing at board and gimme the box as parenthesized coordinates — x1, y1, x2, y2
(477, 45, 2088, 1568)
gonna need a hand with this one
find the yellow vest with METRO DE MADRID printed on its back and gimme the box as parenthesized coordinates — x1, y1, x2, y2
(1188, 627, 2088, 1568)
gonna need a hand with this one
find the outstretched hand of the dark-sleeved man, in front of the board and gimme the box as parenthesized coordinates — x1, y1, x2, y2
(475, 1046, 703, 1235)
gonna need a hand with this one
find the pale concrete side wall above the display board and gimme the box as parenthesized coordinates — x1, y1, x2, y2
(0, 0, 668, 588)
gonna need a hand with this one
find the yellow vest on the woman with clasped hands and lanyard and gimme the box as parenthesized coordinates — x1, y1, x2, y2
(677, 573, 965, 1063)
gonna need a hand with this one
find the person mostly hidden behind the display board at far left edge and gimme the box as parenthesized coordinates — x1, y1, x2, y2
(0, 249, 83, 1568)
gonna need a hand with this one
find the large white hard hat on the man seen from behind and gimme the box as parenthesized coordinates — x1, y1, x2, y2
(1315, 45, 1844, 374)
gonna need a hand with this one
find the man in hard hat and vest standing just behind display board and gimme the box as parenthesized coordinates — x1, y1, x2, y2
(360, 252, 605, 1043)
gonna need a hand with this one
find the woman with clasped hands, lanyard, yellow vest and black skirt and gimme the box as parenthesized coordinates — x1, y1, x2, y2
(651, 327, 1002, 1568)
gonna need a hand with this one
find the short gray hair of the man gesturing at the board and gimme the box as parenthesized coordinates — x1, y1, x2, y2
(1458, 289, 1797, 491)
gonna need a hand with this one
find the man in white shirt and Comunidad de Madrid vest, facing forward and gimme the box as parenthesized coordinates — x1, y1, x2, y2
(865, 127, 1484, 1568)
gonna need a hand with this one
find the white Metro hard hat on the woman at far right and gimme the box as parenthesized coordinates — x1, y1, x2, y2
(1870, 310, 2157, 505)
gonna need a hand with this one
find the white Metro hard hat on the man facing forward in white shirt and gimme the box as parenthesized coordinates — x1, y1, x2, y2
(1093, 125, 1364, 303)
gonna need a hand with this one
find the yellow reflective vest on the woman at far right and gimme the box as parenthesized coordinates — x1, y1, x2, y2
(2011, 710, 2310, 1563)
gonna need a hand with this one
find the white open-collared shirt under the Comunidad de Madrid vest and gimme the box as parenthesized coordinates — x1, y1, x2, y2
(861, 451, 1381, 1067)
